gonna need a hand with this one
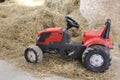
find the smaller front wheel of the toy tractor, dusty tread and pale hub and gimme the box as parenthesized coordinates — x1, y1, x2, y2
(24, 45, 43, 63)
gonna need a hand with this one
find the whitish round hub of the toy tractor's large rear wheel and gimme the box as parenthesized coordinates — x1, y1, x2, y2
(90, 54, 104, 67)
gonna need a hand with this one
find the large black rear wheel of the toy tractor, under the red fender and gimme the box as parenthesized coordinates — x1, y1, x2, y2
(82, 48, 111, 72)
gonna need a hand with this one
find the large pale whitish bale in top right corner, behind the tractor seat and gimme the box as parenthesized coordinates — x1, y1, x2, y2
(80, 0, 120, 24)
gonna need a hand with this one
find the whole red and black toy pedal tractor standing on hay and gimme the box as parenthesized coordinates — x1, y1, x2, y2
(24, 16, 113, 72)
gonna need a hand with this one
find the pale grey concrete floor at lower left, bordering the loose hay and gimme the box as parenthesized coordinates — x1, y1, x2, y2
(0, 60, 69, 80)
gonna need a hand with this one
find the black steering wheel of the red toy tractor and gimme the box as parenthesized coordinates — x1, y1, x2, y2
(65, 16, 80, 30)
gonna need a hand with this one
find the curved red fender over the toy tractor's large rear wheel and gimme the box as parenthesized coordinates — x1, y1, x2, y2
(84, 37, 113, 48)
